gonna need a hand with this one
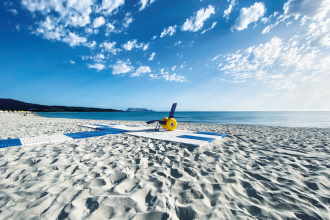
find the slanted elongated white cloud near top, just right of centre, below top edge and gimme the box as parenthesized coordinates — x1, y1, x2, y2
(181, 5, 215, 32)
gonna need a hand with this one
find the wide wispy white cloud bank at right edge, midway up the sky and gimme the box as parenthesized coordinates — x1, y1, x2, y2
(218, 33, 330, 89)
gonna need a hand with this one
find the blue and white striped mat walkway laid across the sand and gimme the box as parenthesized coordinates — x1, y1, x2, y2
(0, 124, 227, 148)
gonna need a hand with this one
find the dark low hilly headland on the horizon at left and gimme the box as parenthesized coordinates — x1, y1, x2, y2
(0, 98, 122, 112)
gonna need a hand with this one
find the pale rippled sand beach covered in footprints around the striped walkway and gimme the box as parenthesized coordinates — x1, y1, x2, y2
(0, 112, 330, 219)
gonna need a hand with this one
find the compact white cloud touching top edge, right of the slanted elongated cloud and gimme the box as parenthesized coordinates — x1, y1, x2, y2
(233, 2, 266, 31)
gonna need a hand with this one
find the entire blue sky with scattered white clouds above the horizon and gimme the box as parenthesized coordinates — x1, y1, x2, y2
(0, 0, 330, 111)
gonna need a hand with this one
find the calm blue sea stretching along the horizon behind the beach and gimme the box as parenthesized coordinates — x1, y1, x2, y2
(38, 111, 330, 128)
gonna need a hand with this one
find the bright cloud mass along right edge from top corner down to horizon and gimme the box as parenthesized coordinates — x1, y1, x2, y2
(213, 0, 330, 110)
